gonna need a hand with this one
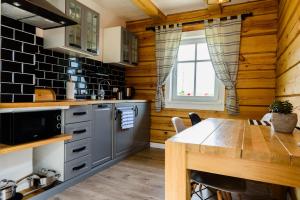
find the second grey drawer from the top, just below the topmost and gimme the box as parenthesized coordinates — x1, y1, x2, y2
(65, 121, 92, 142)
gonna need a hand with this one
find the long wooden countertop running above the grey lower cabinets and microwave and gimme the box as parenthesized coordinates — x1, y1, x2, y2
(0, 100, 148, 109)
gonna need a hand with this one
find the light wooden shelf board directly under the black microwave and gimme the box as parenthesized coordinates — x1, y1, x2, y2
(0, 134, 72, 155)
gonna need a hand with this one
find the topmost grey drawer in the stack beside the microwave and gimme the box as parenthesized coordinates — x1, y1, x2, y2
(65, 106, 92, 124)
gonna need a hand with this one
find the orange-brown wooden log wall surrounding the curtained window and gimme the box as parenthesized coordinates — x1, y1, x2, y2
(126, 0, 278, 143)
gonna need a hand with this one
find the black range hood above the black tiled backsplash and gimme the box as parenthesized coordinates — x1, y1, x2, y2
(1, 0, 77, 29)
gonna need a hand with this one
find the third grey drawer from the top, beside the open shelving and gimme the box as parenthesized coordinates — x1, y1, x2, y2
(65, 138, 91, 162)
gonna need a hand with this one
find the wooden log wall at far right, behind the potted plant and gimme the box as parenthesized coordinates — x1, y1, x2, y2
(276, 0, 300, 127)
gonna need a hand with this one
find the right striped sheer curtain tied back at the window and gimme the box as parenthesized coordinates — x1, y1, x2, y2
(205, 16, 242, 115)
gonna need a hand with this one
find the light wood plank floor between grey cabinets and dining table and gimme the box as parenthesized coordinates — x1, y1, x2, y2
(51, 149, 288, 200)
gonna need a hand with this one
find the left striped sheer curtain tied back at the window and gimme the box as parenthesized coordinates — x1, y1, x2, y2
(155, 24, 182, 112)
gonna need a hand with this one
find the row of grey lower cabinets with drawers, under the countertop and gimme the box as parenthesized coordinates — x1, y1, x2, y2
(64, 103, 150, 180)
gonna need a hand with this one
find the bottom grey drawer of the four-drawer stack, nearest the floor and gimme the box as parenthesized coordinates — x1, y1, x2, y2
(65, 155, 91, 180)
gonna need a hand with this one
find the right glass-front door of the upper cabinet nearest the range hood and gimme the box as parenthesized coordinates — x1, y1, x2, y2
(85, 9, 99, 54)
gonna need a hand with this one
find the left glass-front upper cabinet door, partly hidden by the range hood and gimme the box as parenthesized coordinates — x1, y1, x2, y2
(66, 0, 82, 49)
